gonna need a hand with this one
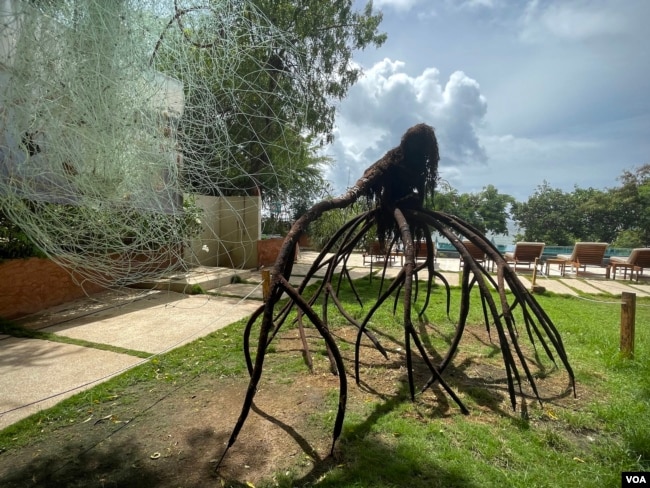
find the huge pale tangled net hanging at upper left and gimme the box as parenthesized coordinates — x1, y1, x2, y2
(0, 0, 307, 286)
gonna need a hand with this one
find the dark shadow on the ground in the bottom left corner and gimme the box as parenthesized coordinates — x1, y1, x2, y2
(0, 429, 266, 488)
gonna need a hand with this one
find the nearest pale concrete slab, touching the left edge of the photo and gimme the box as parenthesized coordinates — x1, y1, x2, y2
(0, 337, 142, 429)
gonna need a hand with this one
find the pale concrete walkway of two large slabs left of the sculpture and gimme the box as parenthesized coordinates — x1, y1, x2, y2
(0, 289, 261, 429)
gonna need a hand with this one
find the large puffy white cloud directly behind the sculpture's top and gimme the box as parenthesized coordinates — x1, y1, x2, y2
(329, 59, 487, 190)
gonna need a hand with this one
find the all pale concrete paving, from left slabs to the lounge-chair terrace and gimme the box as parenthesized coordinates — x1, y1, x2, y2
(0, 252, 650, 429)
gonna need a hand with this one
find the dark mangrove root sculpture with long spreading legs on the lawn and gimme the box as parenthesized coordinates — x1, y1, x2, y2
(219, 124, 575, 464)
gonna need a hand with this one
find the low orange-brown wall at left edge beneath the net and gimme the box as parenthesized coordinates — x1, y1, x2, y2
(0, 258, 102, 319)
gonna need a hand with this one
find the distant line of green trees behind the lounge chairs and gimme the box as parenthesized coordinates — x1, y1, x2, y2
(429, 164, 650, 248)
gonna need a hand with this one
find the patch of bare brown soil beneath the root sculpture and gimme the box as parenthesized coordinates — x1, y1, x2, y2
(0, 327, 574, 488)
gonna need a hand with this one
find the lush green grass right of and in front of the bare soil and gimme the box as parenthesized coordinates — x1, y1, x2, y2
(286, 278, 650, 488)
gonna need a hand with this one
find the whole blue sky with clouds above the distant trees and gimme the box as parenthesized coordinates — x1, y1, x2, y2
(327, 0, 650, 201)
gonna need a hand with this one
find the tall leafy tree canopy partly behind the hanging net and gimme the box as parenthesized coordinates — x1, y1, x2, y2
(154, 0, 386, 202)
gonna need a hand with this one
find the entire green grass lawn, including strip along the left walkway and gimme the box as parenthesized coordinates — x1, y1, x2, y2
(0, 280, 650, 488)
